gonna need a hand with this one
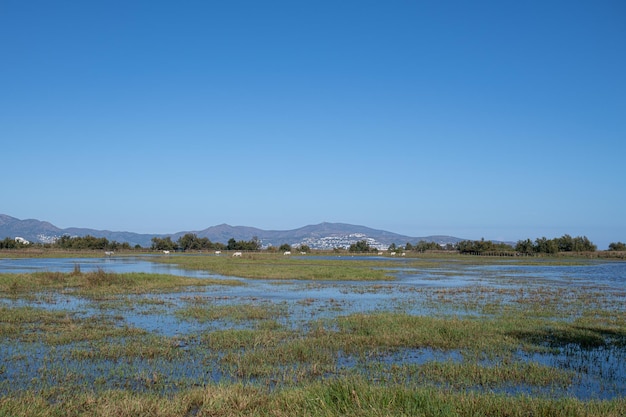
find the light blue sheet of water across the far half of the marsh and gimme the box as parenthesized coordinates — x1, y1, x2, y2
(0, 256, 626, 336)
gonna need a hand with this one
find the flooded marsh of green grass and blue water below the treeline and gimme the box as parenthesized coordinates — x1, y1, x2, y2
(0, 255, 626, 416)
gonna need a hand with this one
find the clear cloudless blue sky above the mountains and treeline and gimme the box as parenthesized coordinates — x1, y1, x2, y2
(0, 0, 626, 249)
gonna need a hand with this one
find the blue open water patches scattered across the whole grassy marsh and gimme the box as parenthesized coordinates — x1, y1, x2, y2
(0, 256, 626, 399)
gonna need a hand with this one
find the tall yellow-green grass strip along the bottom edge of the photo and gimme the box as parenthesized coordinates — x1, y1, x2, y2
(0, 377, 626, 417)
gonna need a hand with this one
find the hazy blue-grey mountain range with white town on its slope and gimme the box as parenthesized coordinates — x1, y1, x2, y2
(0, 214, 465, 249)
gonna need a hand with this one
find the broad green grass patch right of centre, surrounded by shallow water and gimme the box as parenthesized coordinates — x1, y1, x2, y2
(180, 313, 624, 387)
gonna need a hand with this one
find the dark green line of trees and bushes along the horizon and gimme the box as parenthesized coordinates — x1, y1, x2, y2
(0, 233, 626, 255)
